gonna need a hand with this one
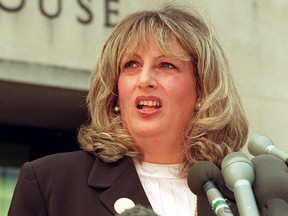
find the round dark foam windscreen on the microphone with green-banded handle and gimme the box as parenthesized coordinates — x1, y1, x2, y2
(187, 161, 225, 196)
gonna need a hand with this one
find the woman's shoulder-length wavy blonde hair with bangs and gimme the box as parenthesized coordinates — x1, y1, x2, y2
(78, 4, 248, 168)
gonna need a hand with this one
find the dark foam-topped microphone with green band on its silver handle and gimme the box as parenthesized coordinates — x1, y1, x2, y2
(187, 161, 233, 216)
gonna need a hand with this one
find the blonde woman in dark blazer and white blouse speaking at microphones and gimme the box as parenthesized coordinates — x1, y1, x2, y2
(9, 5, 248, 216)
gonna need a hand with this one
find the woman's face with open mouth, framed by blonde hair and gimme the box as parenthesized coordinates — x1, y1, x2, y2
(118, 39, 197, 144)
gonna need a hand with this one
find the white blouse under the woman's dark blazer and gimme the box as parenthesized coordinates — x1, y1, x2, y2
(135, 162, 197, 216)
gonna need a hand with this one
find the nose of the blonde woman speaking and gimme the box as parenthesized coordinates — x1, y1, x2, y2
(138, 67, 157, 89)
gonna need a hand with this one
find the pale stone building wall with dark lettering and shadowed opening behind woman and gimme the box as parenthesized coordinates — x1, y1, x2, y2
(0, 0, 288, 216)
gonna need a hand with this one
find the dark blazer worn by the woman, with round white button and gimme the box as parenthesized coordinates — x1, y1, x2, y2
(8, 151, 236, 216)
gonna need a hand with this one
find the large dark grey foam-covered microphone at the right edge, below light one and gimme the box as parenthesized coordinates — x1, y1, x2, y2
(251, 154, 288, 216)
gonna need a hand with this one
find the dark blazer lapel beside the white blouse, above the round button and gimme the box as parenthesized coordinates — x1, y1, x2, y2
(88, 157, 151, 214)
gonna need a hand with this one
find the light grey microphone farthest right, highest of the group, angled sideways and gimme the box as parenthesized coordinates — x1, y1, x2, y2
(248, 134, 288, 165)
